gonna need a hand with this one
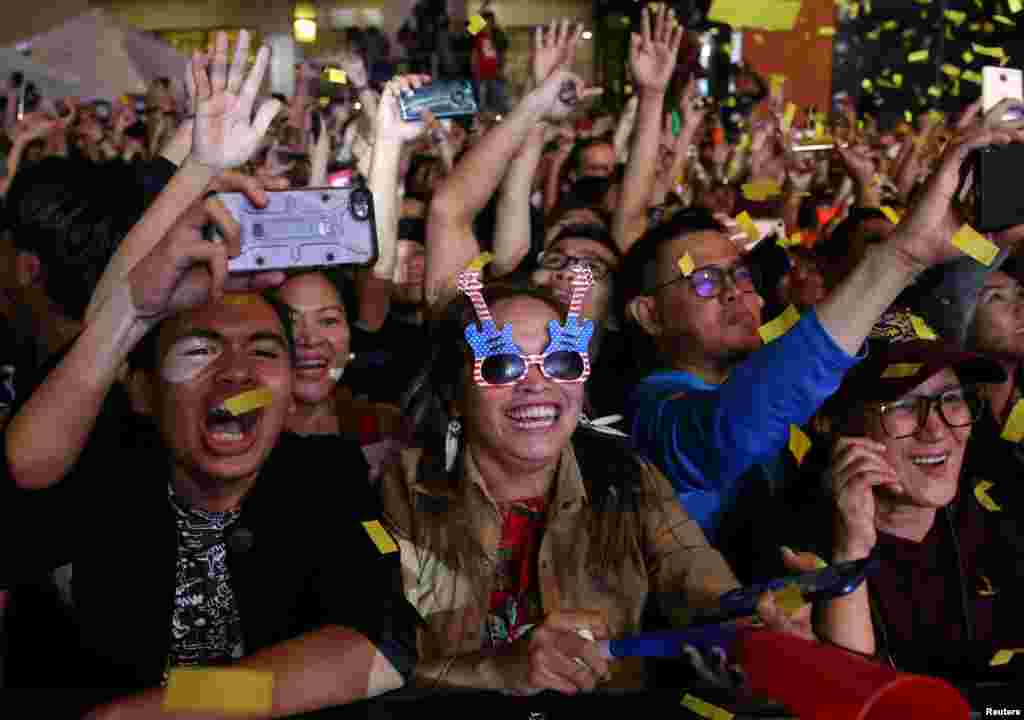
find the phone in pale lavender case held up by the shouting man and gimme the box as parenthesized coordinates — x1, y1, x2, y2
(217, 187, 378, 273)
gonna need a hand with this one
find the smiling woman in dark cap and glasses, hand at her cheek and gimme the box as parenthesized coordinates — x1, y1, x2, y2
(790, 313, 1024, 674)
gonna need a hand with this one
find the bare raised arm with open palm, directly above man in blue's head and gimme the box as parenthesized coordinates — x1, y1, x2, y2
(612, 3, 685, 254)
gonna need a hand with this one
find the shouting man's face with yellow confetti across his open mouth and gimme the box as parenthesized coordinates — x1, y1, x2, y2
(154, 295, 293, 492)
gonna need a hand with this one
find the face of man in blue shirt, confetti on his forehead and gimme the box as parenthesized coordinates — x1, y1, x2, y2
(654, 230, 764, 365)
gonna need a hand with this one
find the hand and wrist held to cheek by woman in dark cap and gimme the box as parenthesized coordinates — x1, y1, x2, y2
(827, 437, 902, 561)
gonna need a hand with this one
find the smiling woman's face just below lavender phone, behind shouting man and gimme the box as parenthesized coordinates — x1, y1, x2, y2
(281, 272, 350, 405)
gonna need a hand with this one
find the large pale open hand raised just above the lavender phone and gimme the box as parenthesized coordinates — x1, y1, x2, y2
(185, 31, 281, 172)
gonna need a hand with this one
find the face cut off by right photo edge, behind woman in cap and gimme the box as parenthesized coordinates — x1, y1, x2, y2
(973, 272, 1024, 362)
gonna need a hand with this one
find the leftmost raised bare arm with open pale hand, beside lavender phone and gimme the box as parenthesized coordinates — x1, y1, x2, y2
(85, 31, 281, 322)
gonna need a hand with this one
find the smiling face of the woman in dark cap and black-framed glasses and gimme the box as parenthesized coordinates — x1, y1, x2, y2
(867, 369, 971, 508)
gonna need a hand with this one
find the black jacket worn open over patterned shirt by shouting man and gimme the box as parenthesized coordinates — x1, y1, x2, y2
(0, 383, 418, 717)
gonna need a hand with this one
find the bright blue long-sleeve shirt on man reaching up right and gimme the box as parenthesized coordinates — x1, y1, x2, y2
(629, 309, 863, 542)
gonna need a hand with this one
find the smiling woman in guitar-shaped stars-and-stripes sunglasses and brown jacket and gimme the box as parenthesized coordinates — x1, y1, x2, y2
(382, 273, 835, 693)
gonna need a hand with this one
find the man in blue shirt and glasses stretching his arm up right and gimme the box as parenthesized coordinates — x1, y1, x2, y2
(623, 122, 1024, 580)
